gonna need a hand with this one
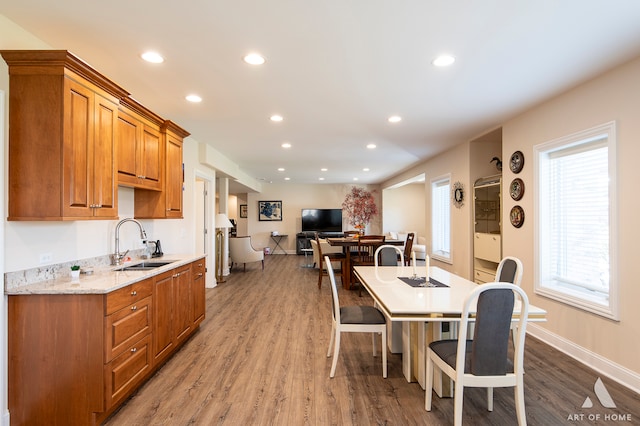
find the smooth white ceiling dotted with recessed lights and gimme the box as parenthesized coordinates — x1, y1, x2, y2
(0, 0, 640, 191)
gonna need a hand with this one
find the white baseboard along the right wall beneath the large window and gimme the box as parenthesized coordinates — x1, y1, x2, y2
(527, 323, 640, 393)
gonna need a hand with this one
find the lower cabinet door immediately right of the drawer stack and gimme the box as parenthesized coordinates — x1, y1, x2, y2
(153, 271, 175, 363)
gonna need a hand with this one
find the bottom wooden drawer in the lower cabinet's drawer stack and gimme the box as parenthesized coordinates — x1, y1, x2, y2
(104, 335, 151, 409)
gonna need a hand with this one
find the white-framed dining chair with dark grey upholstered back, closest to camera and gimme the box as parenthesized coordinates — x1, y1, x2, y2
(425, 283, 529, 426)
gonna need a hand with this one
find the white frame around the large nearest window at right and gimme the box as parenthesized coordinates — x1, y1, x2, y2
(533, 122, 619, 321)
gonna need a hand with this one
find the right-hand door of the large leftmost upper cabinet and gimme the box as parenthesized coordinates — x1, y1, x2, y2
(92, 95, 118, 218)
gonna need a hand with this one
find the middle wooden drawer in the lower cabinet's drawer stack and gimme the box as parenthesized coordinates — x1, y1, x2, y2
(104, 297, 152, 362)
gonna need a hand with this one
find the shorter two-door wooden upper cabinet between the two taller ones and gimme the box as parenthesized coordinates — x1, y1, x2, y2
(117, 98, 164, 191)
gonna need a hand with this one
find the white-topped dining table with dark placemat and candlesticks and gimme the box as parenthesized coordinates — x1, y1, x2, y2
(354, 266, 547, 396)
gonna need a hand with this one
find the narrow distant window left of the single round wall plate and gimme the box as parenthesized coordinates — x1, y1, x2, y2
(431, 176, 453, 263)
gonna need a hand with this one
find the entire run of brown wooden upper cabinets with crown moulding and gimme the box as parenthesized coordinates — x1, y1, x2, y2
(0, 50, 189, 221)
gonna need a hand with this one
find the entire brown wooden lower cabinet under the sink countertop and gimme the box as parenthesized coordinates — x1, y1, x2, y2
(8, 259, 205, 425)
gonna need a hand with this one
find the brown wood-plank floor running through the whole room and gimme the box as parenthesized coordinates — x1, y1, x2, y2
(105, 255, 640, 425)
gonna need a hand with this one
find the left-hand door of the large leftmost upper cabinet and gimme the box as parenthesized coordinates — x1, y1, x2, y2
(62, 78, 94, 217)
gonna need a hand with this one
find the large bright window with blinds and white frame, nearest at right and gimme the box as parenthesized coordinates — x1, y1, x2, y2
(534, 123, 618, 319)
